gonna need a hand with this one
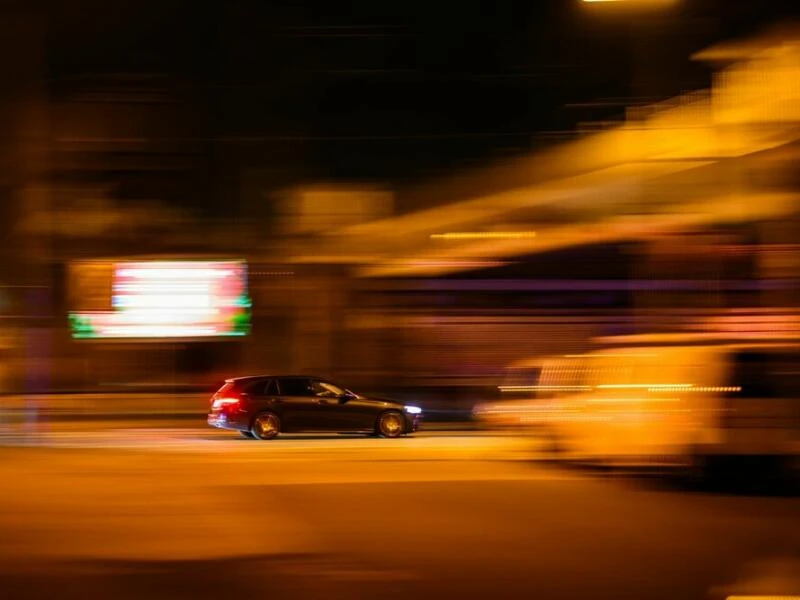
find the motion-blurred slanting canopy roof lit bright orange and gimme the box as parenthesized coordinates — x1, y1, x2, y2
(288, 39, 800, 277)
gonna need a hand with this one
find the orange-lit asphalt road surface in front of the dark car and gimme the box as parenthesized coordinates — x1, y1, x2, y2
(0, 428, 800, 600)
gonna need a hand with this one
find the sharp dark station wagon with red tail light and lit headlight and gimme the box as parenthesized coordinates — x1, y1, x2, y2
(208, 375, 422, 440)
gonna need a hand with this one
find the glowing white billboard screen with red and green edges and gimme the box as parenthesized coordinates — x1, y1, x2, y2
(69, 260, 251, 339)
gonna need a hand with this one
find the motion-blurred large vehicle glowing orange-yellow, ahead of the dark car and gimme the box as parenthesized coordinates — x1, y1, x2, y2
(533, 335, 800, 471)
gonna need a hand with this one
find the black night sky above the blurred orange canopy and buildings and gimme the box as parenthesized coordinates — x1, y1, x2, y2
(42, 0, 798, 181)
